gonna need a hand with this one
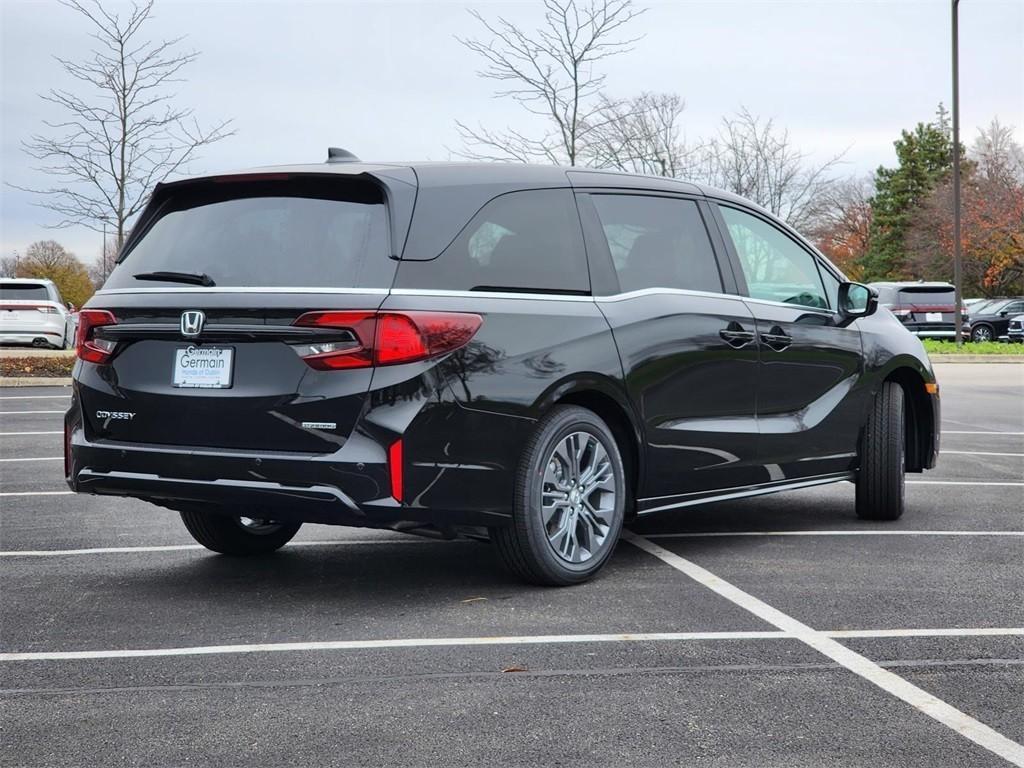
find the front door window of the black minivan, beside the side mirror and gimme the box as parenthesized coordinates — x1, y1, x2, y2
(719, 206, 828, 309)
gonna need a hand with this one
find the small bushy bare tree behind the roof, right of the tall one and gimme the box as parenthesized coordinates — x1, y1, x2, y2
(587, 92, 695, 177)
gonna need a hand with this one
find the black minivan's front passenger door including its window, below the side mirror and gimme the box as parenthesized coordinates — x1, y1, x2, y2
(718, 204, 868, 481)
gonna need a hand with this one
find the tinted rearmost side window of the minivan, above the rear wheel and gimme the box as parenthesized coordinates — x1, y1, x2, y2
(397, 189, 590, 293)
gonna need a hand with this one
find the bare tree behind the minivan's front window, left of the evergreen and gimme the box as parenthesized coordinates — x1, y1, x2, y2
(697, 108, 846, 229)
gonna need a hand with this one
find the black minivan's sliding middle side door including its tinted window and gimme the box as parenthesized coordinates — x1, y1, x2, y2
(579, 190, 758, 511)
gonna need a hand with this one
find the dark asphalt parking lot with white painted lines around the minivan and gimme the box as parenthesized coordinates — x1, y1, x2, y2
(0, 364, 1024, 768)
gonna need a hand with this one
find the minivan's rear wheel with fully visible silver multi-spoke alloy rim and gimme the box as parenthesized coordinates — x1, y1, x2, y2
(490, 406, 628, 587)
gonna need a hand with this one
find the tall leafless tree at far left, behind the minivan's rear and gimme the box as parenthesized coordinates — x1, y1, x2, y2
(18, 0, 233, 247)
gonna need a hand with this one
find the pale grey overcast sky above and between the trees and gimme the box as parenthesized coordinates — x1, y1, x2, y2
(0, 0, 1024, 261)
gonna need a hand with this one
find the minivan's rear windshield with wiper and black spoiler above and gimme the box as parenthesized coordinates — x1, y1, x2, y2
(104, 179, 394, 288)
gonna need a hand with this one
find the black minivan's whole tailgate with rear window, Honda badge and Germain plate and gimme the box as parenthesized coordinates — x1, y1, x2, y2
(77, 174, 405, 453)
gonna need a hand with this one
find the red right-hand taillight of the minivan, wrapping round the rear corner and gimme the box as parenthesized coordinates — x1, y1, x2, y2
(293, 311, 483, 371)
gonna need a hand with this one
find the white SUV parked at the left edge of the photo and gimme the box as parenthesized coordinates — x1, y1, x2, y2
(0, 278, 75, 349)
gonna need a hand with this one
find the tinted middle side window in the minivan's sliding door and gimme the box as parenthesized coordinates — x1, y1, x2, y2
(591, 195, 722, 293)
